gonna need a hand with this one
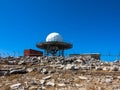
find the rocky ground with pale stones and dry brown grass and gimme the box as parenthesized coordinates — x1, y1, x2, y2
(0, 57, 120, 90)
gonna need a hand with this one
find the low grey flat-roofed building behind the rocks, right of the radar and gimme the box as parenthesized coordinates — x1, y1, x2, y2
(70, 53, 101, 60)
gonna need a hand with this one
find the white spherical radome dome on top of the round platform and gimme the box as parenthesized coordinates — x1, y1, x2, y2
(46, 32, 63, 42)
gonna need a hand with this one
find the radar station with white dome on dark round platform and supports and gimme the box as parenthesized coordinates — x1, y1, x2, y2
(36, 32, 72, 56)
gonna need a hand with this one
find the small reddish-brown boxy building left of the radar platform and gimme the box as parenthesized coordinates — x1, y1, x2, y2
(24, 49, 43, 56)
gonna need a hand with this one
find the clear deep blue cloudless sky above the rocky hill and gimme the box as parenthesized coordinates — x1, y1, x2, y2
(0, 0, 120, 59)
